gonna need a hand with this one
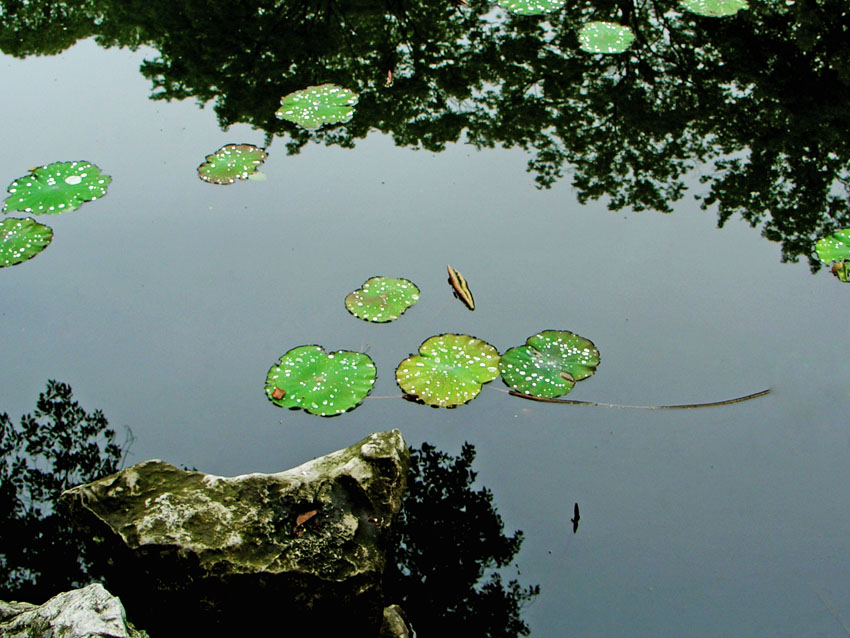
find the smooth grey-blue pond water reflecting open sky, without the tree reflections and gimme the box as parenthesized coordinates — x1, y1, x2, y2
(0, 2, 850, 637)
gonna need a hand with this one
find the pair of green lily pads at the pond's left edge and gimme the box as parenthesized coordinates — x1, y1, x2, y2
(0, 161, 112, 268)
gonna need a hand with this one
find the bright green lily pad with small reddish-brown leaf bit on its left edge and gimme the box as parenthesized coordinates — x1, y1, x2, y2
(266, 345, 378, 416)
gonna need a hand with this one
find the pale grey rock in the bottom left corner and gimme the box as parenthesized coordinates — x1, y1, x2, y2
(0, 584, 147, 638)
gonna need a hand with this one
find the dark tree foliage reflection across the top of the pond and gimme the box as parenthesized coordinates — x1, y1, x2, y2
(0, 0, 850, 268)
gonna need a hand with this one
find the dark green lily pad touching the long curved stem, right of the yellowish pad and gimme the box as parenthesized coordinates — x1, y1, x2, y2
(499, 330, 599, 399)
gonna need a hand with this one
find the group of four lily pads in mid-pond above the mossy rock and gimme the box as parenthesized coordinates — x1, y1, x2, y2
(265, 268, 599, 416)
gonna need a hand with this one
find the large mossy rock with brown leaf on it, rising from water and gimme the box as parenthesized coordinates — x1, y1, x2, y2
(62, 430, 410, 638)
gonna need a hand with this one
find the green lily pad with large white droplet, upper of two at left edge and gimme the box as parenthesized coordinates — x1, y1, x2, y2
(3, 161, 112, 215)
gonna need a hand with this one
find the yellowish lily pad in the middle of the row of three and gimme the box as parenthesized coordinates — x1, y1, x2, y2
(395, 334, 499, 408)
